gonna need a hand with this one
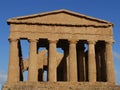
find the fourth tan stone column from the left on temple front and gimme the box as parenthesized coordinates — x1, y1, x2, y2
(69, 41, 77, 82)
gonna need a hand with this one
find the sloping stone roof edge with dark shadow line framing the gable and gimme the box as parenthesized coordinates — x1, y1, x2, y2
(7, 9, 113, 26)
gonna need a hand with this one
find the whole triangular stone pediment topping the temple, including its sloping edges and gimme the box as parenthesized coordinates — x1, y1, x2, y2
(8, 10, 112, 26)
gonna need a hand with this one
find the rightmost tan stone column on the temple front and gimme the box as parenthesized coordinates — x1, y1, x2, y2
(106, 42, 115, 83)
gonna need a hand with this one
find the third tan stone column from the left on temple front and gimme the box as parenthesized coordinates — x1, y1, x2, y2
(48, 40, 57, 82)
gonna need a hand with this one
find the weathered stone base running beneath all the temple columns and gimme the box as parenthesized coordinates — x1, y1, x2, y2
(2, 82, 120, 90)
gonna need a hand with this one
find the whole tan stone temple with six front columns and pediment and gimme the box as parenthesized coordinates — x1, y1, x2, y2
(2, 10, 120, 90)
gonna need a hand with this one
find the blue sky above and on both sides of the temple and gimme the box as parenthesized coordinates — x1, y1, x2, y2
(0, 0, 120, 87)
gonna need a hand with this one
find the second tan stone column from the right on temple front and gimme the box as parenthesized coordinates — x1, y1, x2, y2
(88, 41, 96, 82)
